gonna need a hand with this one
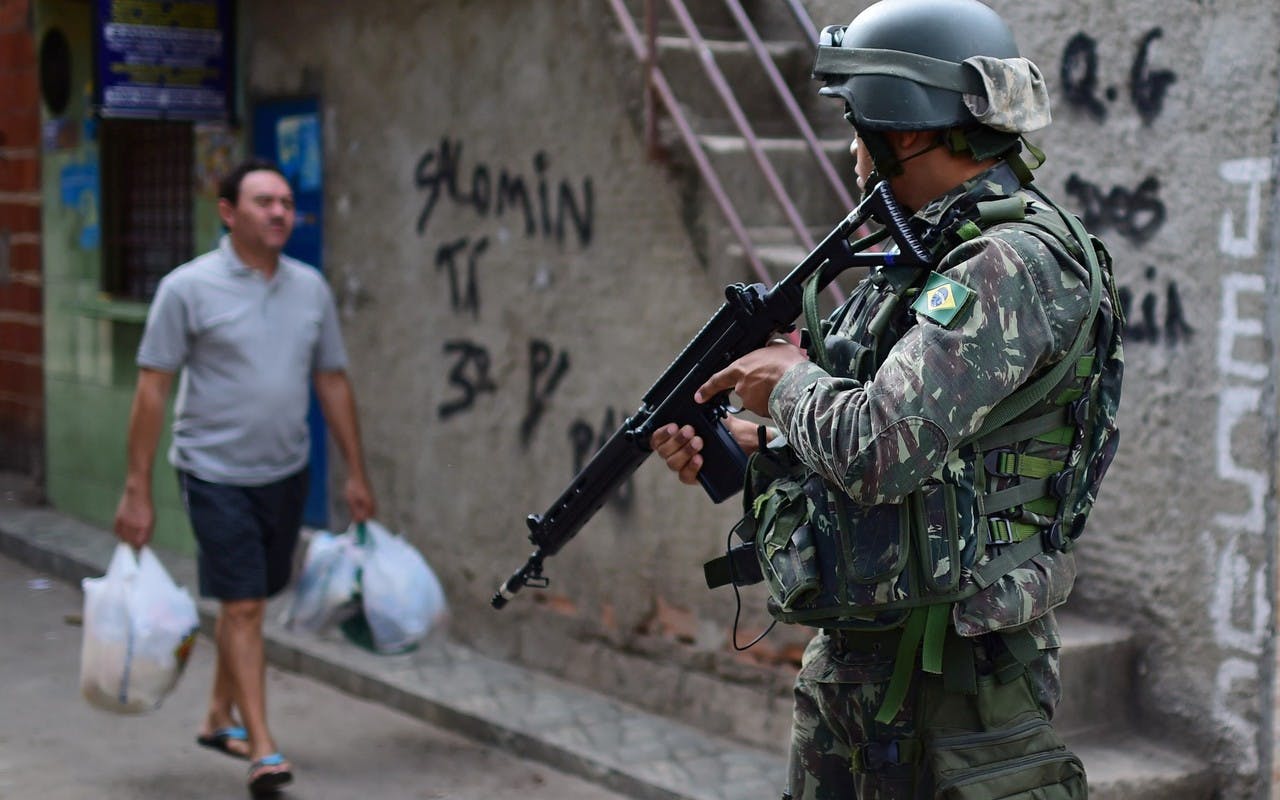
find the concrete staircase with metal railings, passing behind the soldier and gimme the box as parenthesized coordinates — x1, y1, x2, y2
(608, 0, 1215, 800)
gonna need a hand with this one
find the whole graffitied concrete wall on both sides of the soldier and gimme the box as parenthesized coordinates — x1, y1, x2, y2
(244, 0, 1280, 796)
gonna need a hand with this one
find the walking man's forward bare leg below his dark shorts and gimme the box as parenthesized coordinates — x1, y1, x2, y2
(215, 599, 289, 772)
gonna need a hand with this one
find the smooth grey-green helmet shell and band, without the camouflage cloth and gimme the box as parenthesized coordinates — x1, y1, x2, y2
(814, 0, 1019, 131)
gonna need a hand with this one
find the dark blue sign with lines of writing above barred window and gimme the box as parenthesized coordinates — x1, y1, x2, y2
(93, 0, 232, 119)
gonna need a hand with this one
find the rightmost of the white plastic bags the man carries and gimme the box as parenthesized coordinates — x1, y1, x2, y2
(360, 520, 447, 653)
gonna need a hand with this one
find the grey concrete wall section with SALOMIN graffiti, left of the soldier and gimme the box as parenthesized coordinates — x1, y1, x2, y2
(244, 1, 797, 746)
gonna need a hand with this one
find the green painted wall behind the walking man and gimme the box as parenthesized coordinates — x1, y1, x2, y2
(35, 0, 242, 553)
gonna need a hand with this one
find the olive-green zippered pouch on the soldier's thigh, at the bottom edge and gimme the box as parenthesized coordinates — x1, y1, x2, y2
(924, 673, 1089, 800)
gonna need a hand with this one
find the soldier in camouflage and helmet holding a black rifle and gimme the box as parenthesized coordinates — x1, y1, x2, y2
(652, 0, 1123, 800)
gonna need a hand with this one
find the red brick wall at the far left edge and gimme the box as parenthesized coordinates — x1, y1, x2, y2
(0, 0, 44, 474)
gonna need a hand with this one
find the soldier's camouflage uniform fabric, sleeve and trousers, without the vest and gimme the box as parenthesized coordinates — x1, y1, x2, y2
(769, 164, 1110, 800)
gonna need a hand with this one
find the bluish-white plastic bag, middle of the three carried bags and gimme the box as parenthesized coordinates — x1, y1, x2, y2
(284, 531, 365, 634)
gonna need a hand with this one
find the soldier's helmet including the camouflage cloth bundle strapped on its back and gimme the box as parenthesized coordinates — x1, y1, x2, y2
(813, 0, 1050, 133)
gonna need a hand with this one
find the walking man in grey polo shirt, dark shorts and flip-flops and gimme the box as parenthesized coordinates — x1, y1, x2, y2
(115, 160, 375, 792)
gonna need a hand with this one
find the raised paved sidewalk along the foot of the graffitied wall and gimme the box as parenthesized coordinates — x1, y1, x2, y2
(0, 493, 786, 800)
